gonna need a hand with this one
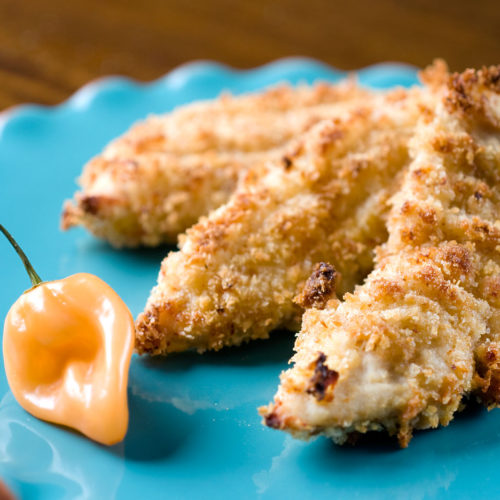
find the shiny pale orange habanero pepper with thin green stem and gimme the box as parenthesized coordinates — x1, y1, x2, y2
(0, 225, 135, 445)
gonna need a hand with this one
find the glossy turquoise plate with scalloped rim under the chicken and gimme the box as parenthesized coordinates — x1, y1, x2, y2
(0, 59, 500, 500)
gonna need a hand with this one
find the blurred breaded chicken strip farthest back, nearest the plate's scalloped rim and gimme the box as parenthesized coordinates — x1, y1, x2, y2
(62, 81, 372, 247)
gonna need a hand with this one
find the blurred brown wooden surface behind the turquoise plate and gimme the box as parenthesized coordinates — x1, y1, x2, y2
(0, 0, 500, 109)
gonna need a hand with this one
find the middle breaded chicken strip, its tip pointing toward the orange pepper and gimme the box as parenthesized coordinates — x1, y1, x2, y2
(136, 79, 438, 354)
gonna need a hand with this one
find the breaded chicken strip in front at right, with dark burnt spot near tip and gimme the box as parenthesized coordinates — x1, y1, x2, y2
(261, 66, 500, 447)
